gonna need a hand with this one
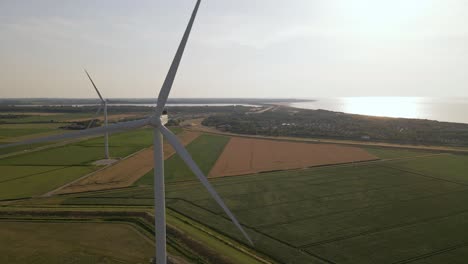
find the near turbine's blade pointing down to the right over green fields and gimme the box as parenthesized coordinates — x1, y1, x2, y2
(159, 126, 253, 246)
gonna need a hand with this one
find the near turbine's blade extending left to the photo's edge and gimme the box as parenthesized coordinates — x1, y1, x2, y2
(0, 118, 149, 149)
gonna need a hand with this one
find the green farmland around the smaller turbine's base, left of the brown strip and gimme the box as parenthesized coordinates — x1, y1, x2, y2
(0, 129, 157, 199)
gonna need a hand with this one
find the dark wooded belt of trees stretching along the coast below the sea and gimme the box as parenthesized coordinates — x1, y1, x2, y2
(202, 107, 468, 146)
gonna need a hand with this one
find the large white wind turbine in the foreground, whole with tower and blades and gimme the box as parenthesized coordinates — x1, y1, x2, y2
(0, 0, 253, 264)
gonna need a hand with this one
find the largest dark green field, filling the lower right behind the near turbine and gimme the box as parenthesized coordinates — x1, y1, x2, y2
(65, 154, 468, 264)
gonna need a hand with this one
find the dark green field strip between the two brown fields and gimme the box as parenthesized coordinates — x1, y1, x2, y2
(136, 135, 229, 185)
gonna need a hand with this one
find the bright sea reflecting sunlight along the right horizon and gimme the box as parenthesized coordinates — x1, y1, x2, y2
(289, 97, 468, 124)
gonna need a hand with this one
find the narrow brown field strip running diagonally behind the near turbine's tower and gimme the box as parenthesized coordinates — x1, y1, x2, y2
(53, 131, 200, 194)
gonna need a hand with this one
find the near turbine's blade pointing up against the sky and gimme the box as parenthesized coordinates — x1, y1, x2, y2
(156, 0, 201, 117)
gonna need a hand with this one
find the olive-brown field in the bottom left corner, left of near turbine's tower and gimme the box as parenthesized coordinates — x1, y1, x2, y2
(0, 221, 154, 264)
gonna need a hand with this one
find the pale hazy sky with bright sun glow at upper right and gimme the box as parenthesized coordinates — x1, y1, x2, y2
(0, 0, 468, 98)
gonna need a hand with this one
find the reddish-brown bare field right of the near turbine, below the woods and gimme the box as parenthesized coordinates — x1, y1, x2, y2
(210, 137, 378, 177)
